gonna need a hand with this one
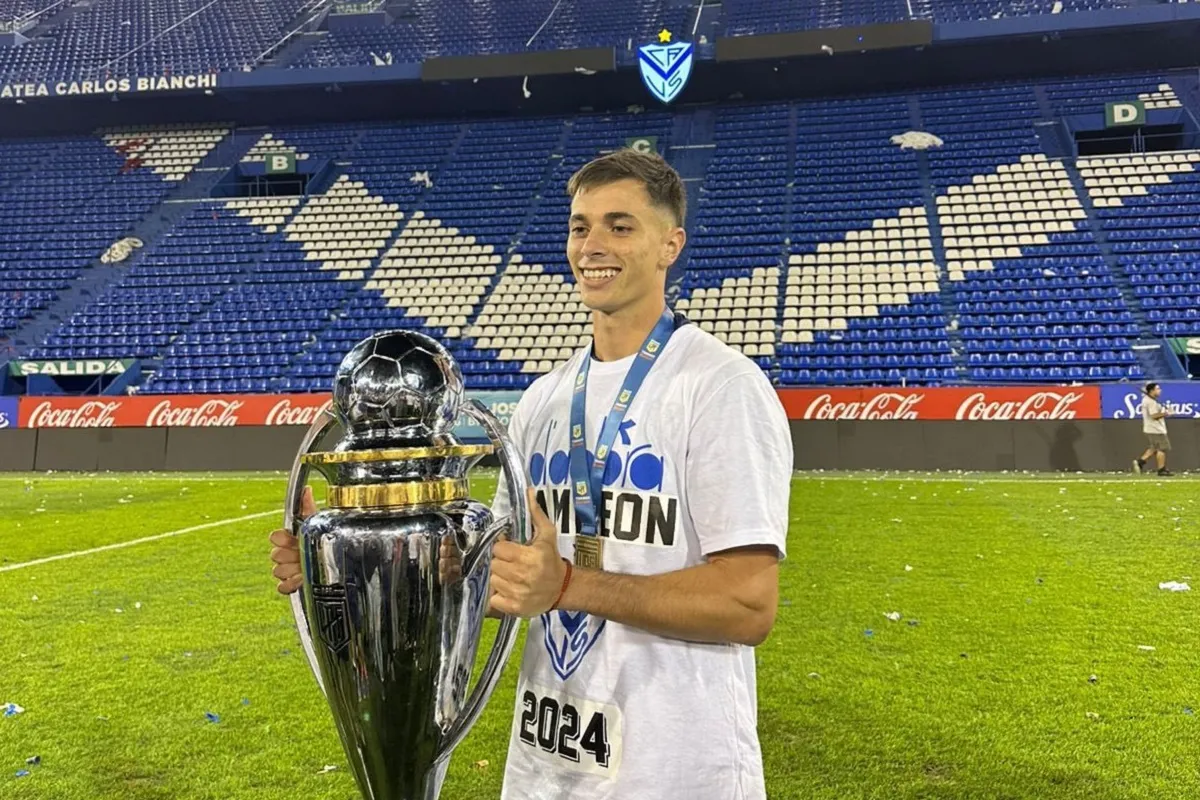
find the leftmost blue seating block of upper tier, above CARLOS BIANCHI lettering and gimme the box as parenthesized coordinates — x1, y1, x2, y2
(0, 0, 319, 83)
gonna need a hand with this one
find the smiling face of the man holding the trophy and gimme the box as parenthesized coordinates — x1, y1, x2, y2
(566, 179, 685, 314)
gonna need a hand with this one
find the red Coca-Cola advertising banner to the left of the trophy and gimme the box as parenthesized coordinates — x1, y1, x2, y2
(18, 395, 330, 428)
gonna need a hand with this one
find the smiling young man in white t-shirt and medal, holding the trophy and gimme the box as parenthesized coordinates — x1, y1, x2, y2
(271, 150, 792, 800)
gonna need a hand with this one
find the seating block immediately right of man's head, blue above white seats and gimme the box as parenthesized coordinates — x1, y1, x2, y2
(677, 106, 792, 368)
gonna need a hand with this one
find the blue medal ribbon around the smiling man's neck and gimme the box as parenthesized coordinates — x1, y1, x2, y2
(570, 308, 686, 536)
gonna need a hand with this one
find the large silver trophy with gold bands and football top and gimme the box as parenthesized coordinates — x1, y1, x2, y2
(284, 331, 529, 800)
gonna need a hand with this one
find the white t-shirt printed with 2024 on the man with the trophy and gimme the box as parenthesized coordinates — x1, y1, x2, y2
(494, 325, 792, 800)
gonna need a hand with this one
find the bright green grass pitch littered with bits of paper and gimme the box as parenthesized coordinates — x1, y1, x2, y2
(0, 475, 1200, 800)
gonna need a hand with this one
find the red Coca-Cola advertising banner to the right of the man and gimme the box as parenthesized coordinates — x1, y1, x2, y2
(779, 386, 1100, 421)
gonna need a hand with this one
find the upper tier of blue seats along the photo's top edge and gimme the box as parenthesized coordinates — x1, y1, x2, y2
(0, 0, 1171, 77)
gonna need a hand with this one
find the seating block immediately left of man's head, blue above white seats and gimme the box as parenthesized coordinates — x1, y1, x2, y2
(469, 113, 671, 384)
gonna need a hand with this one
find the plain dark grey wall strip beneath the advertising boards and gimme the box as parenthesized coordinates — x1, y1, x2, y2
(0, 420, 1200, 473)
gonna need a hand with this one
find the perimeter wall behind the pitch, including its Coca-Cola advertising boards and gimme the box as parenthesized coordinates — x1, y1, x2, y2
(0, 381, 1200, 473)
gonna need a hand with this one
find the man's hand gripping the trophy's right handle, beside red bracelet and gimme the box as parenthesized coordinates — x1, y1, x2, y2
(492, 488, 566, 619)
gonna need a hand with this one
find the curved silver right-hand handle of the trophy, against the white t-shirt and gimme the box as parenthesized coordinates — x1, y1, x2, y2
(434, 399, 530, 764)
